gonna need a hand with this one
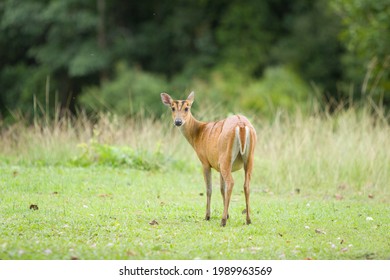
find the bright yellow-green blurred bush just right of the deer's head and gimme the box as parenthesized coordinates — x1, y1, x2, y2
(187, 65, 311, 116)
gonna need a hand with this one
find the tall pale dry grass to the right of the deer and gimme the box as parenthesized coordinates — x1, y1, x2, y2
(256, 108, 390, 200)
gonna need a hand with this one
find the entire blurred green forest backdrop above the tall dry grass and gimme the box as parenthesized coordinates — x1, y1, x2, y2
(0, 0, 390, 118)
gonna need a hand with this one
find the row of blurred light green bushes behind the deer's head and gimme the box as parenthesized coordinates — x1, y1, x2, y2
(80, 64, 310, 116)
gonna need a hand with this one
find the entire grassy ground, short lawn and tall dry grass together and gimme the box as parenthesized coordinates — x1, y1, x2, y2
(0, 107, 390, 260)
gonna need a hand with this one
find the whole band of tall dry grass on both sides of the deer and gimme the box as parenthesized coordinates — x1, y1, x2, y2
(0, 106, 390, 201)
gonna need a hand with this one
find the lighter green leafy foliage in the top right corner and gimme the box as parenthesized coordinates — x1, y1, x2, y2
(330, 0, 390, 104)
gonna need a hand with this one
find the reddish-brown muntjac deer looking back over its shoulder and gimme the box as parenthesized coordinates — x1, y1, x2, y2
(161, 92, 256, 226)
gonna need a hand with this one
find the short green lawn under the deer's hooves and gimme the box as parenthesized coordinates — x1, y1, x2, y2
(0, 166, 390, 259)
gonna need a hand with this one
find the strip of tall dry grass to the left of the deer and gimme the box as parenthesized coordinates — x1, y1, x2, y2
(0, 114, 184, 165)
